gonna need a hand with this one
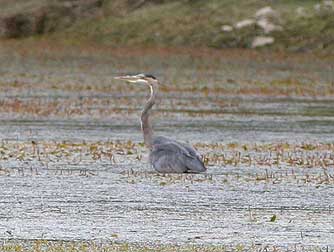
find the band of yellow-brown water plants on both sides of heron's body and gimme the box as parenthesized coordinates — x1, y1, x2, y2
(0, 141, 334, 185)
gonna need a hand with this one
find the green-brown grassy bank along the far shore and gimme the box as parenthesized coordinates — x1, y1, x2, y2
(0, 0, 334, 53)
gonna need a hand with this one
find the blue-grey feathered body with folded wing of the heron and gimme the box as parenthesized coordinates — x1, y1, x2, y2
(150, 137, 206, 173)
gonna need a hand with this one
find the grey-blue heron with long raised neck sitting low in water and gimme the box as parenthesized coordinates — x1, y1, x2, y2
(115, 74, 206, 173)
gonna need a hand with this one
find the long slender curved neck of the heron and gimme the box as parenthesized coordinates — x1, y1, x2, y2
(141, 83, 158, 149)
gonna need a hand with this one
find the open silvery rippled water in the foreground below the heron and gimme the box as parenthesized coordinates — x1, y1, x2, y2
(0, 171, 334, 246)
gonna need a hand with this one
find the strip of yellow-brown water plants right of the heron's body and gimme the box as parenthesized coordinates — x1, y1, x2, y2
(195, 143, 334, 169)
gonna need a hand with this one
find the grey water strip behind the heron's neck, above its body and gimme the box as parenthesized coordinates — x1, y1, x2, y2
(0, 97, 334, 143)
